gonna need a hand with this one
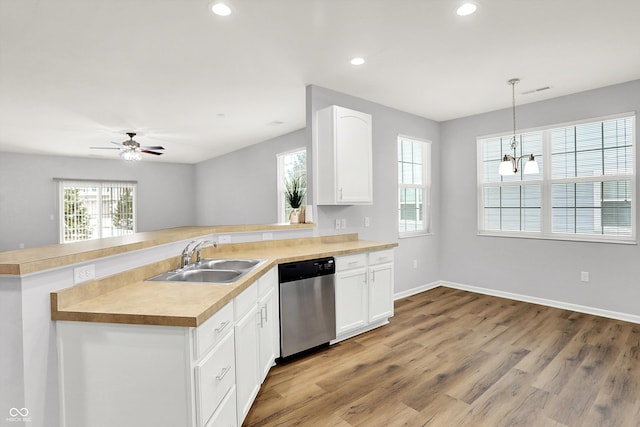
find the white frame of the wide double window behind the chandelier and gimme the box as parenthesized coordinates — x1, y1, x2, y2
(476, 112, 637, 244)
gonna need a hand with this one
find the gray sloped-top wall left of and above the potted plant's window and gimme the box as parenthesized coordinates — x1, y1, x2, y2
(195, 129, 306, 225)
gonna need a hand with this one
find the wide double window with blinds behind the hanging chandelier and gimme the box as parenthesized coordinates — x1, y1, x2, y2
(478, 115, 635, 242)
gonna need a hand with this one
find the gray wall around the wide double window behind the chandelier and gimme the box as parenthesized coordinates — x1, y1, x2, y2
(440, 80, 640, 315)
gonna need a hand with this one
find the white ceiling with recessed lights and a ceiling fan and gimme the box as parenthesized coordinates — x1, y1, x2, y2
(0, 0, 640, 163)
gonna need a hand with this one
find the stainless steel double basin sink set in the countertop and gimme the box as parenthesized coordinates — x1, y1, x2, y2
(147, 258, 266, 284)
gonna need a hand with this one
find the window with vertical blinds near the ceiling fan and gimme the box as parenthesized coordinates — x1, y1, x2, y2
(59, 180, 136, 243)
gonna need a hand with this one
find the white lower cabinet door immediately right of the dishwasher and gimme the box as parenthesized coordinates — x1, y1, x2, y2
(335, 268, 368, 336)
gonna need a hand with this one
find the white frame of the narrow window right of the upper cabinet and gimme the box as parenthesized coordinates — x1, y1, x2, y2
(396, 134, 433, 239)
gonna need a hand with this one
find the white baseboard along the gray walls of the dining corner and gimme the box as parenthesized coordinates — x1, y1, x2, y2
(394, 280, 640, 324)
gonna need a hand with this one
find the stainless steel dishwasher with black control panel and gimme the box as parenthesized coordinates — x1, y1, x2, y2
(278, 257, 336, 358)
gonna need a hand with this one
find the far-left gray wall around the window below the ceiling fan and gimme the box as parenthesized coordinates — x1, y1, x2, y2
(0, 152, 195, 251)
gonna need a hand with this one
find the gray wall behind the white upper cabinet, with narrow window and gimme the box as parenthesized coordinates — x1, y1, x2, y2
(307, 86, 442, 293)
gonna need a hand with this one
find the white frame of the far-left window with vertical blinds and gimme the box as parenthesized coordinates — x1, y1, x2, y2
(54, 178, 138, 244)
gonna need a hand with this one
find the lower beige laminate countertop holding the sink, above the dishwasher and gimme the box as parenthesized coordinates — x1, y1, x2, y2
(51, 234, 397, 326)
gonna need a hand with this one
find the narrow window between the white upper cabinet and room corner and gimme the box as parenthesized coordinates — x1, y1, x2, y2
(398, 136, 431, 237)
